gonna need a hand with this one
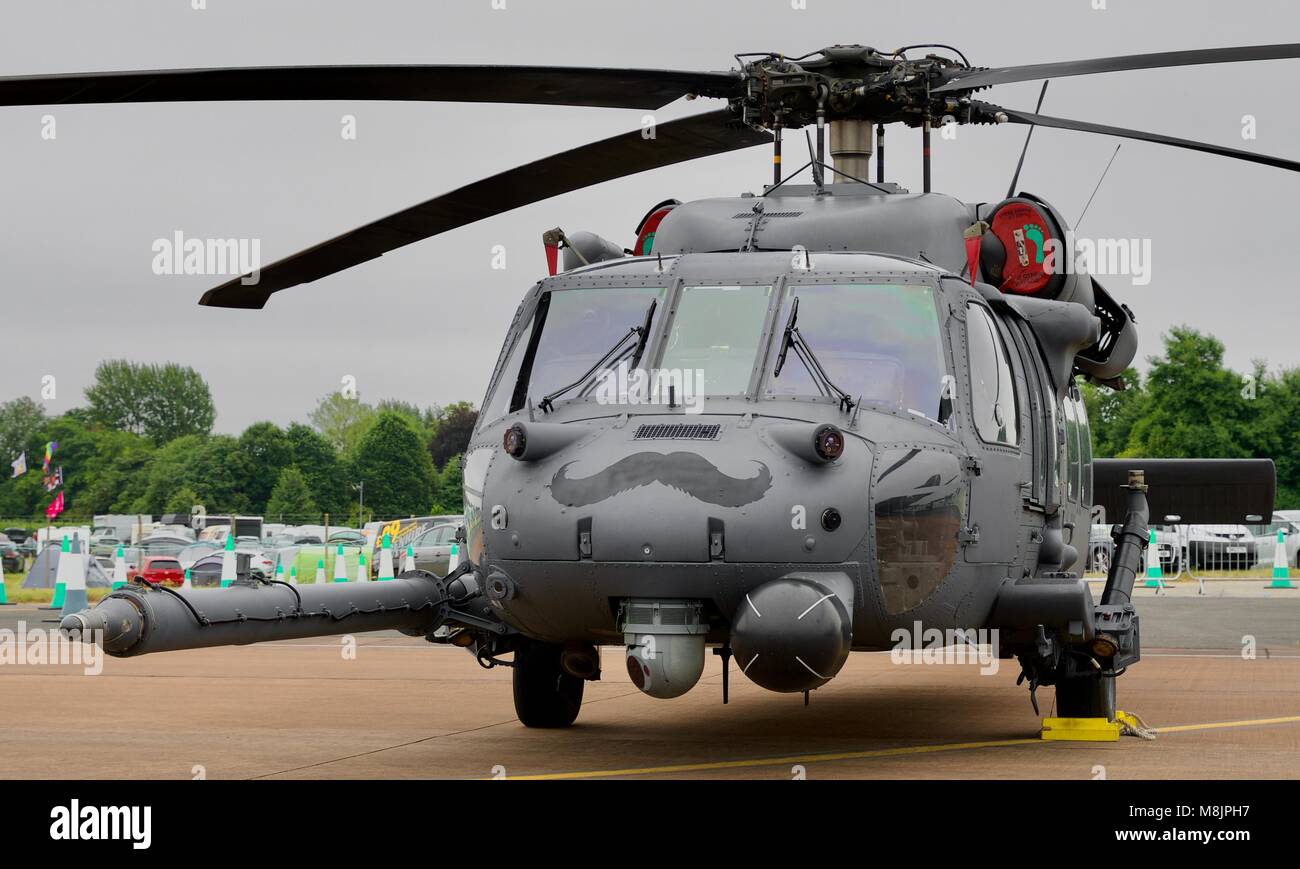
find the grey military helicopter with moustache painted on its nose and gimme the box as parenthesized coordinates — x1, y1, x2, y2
(15, 44, 1284, 727)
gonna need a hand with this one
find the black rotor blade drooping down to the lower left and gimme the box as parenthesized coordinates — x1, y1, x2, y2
(199, 109, 772, 308)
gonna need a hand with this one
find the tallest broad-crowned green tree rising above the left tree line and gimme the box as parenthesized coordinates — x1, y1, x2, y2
(86, 359, 217, 445)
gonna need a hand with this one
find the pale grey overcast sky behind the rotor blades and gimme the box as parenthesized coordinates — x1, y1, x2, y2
(0, 0, 1300, 432)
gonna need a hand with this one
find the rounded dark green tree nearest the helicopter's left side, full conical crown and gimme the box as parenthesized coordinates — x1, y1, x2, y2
(352, 411, 434, 518)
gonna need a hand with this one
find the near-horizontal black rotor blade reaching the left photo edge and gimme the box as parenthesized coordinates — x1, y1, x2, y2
(0, 65, 744, 109)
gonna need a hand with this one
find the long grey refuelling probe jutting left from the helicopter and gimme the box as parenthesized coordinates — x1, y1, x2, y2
(59, 576, 447, 658)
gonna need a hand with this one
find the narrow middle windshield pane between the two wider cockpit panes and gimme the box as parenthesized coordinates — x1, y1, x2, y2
(659, 286, 772, 395)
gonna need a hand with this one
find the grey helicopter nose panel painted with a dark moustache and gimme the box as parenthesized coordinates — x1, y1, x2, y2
(482, 415, 872, 563)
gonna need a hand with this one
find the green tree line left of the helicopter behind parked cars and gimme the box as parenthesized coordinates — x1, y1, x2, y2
(0, 360, 477, 524)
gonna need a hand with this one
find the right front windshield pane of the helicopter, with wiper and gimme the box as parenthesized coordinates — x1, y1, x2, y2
(764, 284, 948, 419)
